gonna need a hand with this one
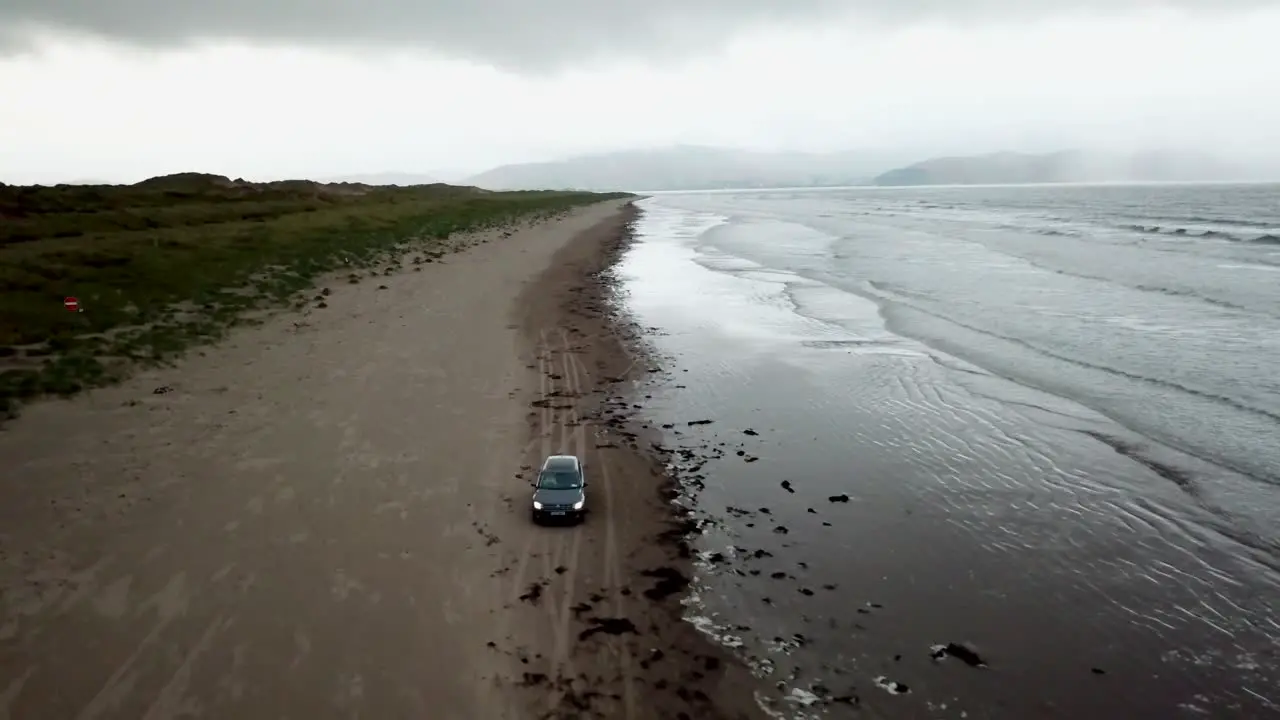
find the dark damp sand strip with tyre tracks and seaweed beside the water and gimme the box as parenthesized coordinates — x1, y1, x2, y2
(499, 202, 763, 720)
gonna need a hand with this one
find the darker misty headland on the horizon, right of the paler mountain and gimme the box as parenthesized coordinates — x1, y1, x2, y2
(873, 150, 1254, 186)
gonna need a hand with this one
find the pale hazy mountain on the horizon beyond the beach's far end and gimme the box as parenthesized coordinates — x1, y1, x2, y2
(461, 145, 909, 191)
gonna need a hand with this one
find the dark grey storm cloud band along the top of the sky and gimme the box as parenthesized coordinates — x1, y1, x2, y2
(0, 0, 1275, 72)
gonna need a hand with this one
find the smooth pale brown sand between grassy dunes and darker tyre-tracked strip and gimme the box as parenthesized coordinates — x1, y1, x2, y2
(0, 200, 626, 720)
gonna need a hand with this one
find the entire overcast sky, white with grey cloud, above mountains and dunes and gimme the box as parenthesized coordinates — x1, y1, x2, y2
(0, 0, 1280, 182)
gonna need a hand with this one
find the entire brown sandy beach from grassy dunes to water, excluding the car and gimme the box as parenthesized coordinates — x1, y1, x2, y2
(0, 201, 753, 720)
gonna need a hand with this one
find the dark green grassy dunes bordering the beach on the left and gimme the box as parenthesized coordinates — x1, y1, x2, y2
(0, 173, 625, 414)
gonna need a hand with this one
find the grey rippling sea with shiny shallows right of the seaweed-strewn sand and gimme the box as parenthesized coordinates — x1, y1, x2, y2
(616, 184, 1280, 720)
